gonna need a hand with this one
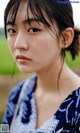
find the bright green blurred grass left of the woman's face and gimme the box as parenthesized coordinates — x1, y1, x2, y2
(0, 37, 19, 75)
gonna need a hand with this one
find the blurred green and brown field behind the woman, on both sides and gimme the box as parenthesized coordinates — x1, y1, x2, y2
(0, 29, 80, 123)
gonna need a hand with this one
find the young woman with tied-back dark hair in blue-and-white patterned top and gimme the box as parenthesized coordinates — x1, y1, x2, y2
(3, 0, 80, 133)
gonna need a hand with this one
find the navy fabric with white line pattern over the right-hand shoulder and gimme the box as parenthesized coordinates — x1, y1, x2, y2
(56, 87, 80, 133)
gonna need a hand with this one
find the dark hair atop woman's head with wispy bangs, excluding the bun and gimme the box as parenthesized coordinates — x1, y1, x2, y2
(4, 0, 74, 36)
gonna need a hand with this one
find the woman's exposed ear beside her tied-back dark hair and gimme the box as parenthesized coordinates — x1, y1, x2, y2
(62, 27, 74, 48)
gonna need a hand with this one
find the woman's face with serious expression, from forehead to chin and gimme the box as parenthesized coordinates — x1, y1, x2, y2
(7, 1, 61, 72)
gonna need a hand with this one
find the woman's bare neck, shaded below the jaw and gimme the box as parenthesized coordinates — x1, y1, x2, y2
(37, 56, 64, 93)
